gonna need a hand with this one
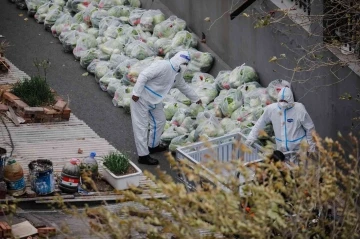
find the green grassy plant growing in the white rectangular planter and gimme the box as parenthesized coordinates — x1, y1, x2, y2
(104, 152, 130, 175)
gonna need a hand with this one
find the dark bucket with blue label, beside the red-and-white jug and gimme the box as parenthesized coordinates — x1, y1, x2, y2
(29, 159, 55, 195)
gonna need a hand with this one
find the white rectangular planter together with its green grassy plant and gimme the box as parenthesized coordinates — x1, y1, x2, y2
(103, 152, 142, 190)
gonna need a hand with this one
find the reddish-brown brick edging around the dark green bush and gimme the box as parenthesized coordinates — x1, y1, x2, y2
(2, 91, 71, 123)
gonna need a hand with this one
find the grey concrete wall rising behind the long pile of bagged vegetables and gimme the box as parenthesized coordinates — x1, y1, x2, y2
(142, 0, 360, 137)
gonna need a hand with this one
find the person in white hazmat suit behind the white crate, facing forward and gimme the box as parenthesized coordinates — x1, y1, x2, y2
(246, 87, 315, 152)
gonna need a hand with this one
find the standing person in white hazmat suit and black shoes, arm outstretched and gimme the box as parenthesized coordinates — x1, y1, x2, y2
(130, 51, 202, 165)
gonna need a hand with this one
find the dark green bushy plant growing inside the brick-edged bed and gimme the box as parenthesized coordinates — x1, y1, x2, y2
(11, 76, 55, 107)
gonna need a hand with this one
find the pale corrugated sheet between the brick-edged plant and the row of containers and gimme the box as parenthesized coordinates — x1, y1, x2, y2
(0, 114, 116, 173)
